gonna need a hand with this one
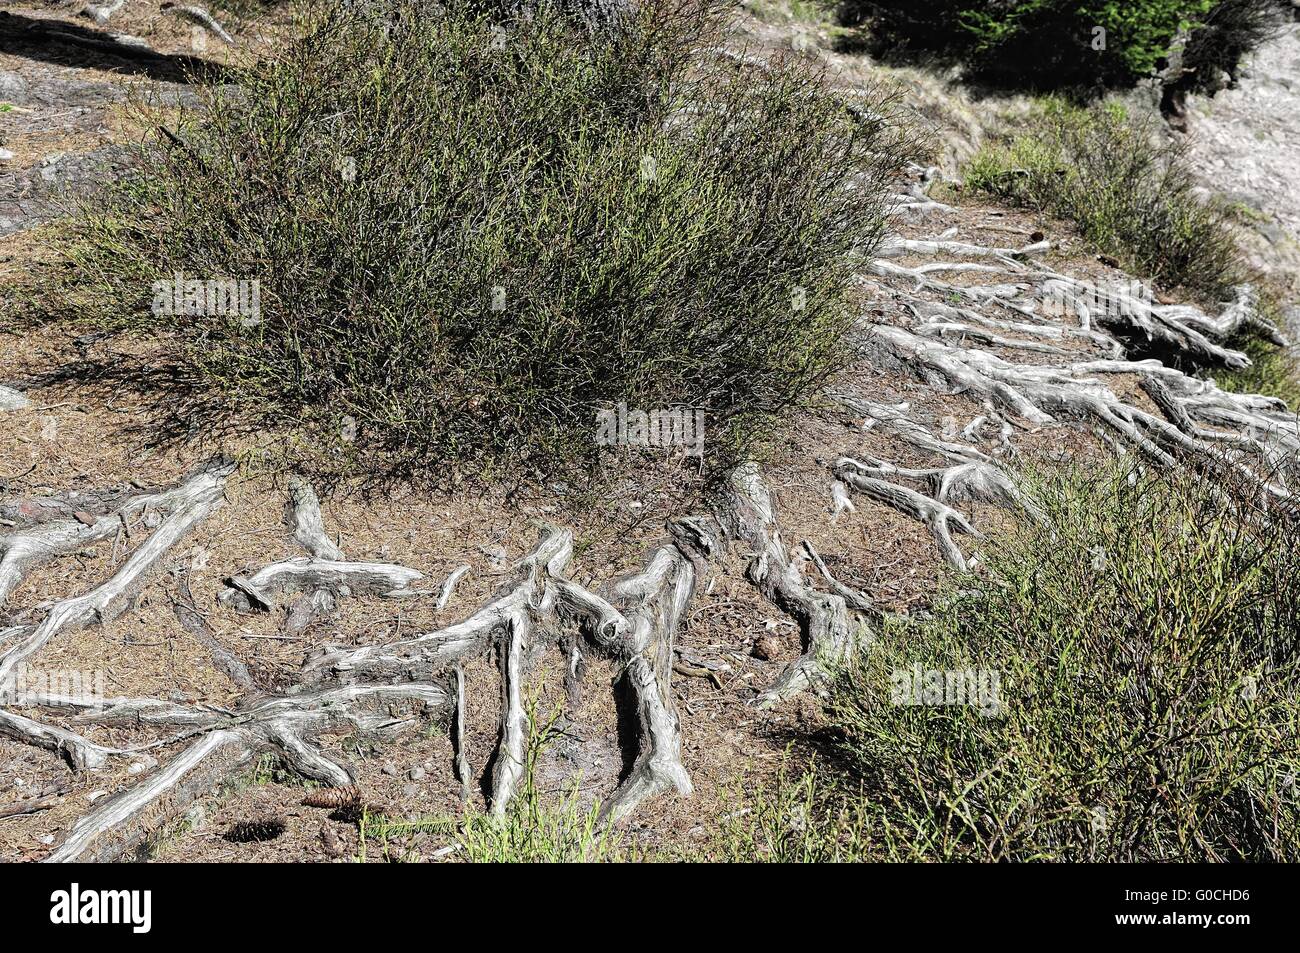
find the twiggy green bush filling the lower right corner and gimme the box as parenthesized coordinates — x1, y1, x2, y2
(832, 462, 1300, 861)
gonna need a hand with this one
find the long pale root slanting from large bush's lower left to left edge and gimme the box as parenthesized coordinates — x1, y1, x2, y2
(0, 464, 234, 689)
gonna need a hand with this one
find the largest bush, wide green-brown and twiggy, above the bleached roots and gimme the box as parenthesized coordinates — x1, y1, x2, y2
(58, 0, 914, 478)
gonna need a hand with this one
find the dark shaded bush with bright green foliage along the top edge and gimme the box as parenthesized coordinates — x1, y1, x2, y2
(841, 0, 1286, 90)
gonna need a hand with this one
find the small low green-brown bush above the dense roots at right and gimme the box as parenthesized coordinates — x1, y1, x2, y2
(966, 99, 1242, 298)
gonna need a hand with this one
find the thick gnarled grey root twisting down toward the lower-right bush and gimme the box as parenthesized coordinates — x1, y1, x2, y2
(724, 464, 859, 707)
